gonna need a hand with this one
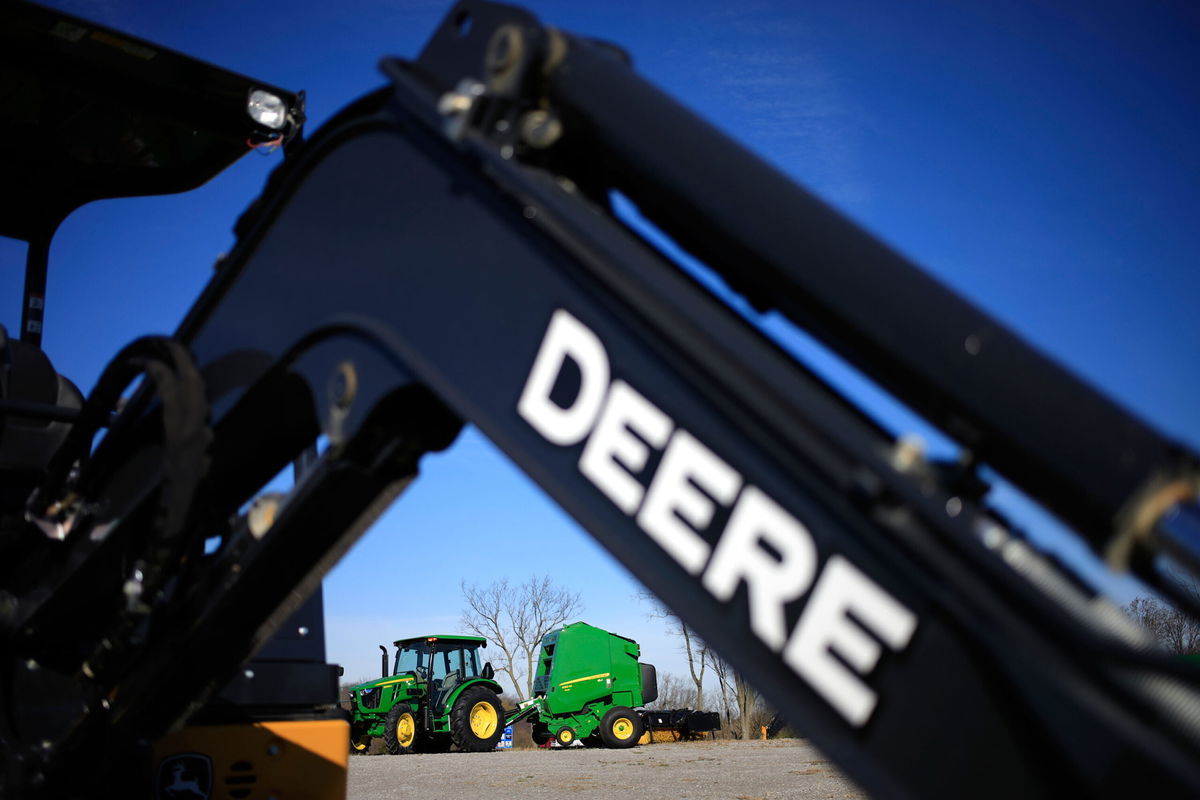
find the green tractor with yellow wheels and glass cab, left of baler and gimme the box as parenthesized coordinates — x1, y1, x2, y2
(350, 636, 504, 754)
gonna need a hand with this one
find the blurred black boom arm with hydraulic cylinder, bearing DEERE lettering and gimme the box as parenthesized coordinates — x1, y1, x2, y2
(4, 2, 1200, 798)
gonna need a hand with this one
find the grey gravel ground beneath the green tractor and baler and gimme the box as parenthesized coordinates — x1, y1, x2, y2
(347, 739, 866, 800)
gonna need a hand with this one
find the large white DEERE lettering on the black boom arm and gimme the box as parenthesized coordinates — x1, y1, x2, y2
(517, 309, 917, 726)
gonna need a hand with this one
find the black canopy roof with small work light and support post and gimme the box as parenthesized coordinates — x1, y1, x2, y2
(0, 0, 304, 347)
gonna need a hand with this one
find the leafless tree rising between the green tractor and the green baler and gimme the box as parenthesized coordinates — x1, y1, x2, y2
(461, 576, 583, 702)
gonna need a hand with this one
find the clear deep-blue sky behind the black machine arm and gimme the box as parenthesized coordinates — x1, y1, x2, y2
(0, 0, 1200, 690)
